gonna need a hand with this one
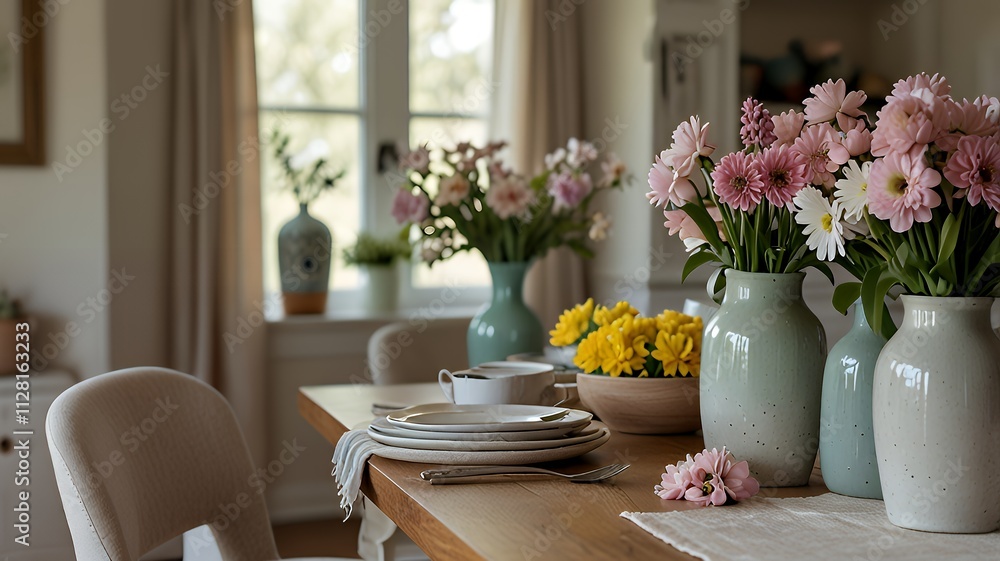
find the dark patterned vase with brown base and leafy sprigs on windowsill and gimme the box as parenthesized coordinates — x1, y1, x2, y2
(271, 130, 345, 314)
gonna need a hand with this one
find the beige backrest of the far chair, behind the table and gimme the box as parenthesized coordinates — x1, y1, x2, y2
(368, 318, 472, 386)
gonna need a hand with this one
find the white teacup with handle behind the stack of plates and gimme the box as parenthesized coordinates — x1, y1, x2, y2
(438, 362, 571, 405)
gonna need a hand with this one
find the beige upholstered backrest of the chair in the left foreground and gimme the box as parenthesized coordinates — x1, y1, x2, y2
(45, 368, 278, 561)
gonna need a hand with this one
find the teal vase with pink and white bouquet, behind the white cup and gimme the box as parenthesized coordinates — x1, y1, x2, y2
(392, 138, 625, 365)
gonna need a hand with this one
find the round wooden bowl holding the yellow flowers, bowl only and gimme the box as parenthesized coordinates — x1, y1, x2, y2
(576, 373, 701, 434)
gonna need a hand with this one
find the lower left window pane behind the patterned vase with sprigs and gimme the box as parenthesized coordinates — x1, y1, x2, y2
(260, 111, 361, 293)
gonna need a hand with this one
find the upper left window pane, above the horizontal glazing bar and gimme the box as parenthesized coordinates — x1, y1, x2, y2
(254, 0, 360, 108)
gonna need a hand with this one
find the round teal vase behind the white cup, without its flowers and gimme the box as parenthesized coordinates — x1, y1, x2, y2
(467, 262, 544, 366)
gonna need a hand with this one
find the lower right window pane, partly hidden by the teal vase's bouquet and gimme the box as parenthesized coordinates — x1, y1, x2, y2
(410, 118, 490, 288)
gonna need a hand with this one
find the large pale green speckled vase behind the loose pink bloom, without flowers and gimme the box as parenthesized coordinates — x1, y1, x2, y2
(701, 269, 826, 487)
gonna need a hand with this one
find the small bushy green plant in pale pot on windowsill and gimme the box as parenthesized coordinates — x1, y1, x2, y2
(344, 231, 413, 313)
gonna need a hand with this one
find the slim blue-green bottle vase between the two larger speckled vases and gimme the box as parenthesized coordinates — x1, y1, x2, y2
(819, 300, 885, 499)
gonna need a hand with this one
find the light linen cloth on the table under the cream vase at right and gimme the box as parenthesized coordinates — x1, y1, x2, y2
(621, 493, 1000, 561)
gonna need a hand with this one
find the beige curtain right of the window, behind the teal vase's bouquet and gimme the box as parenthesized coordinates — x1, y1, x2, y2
(490, 0, 586, 326)
